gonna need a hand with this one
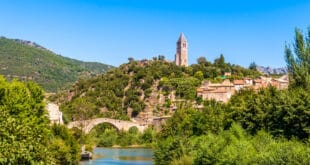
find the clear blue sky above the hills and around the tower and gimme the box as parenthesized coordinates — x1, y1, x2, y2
(0, 0, 310, 67)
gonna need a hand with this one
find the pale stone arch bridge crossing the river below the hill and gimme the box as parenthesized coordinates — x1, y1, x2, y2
(67, 118, 147, 133)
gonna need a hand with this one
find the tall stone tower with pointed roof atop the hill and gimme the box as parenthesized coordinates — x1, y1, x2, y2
(174, 33, 188, 66)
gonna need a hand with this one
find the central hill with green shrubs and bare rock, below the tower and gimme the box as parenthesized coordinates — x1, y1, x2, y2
(52, 55, 260, 122)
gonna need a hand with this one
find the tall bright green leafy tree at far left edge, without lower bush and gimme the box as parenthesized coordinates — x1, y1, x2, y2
(0, 76, 55, 164)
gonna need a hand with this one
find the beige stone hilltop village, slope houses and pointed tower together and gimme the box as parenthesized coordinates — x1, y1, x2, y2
(174, 33, 289, 102)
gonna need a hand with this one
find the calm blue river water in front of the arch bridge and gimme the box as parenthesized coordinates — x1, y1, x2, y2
(80, 147, 153, 165)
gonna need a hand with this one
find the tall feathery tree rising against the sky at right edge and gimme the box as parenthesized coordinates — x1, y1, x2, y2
(285, 27, 310, 89)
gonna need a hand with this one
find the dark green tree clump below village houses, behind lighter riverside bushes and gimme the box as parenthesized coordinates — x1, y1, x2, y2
(225, 87, 310, 139)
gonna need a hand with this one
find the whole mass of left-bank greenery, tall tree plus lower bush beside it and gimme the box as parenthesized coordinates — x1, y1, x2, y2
(0, 76, 80, 165)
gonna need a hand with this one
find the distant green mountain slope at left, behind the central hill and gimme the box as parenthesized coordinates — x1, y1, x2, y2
(0, 37, 112, 92)
